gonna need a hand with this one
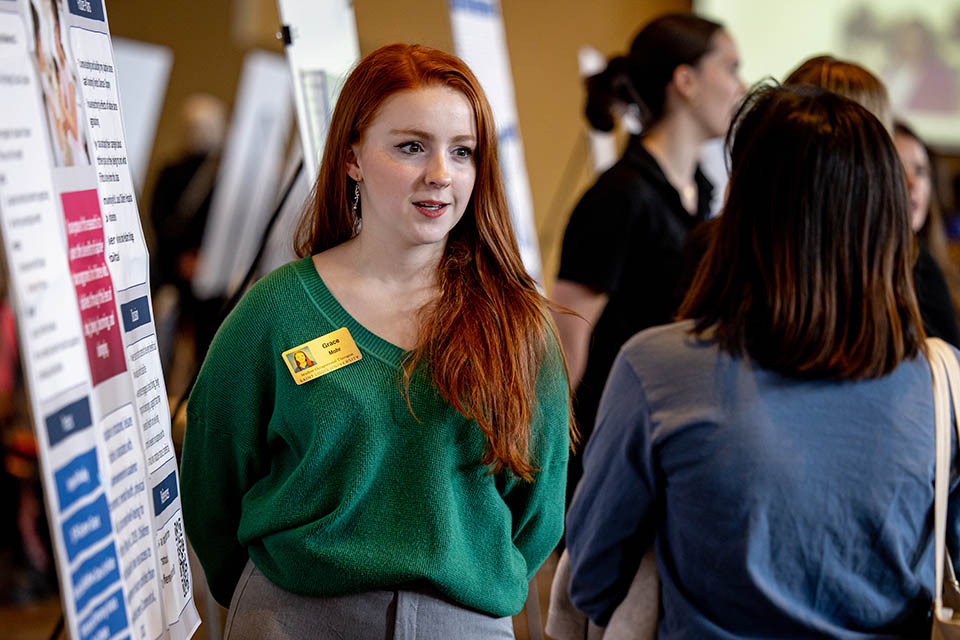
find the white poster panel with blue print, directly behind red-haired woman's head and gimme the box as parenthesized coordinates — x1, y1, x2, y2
(449, 0, 543, 283)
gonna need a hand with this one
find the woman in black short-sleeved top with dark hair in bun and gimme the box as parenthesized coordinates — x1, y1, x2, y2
(553, 14, 744, 501)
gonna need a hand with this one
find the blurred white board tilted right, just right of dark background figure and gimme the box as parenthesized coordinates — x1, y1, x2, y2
(193, 51, 293, 299)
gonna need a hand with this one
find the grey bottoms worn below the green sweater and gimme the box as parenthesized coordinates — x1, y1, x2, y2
(225, 560, 514, 640)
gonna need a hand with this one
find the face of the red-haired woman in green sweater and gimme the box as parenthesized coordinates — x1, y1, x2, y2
(347, 85, 477, 250)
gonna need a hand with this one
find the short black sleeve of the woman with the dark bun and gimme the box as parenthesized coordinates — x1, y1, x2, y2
(557, 174, 642, 293)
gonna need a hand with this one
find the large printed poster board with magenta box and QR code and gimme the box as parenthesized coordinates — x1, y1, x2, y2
(0, 0, 200, 640)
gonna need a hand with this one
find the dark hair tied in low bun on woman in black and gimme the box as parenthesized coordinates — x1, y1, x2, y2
(585, 13, 723, 131)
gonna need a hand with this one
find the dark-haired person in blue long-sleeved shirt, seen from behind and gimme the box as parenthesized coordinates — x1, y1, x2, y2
(567, 86, 960, 640)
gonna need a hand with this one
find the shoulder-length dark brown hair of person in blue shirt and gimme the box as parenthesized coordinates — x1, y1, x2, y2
(679, 86, 924, 380)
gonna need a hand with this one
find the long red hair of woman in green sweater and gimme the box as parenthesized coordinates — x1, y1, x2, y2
(295, 44, 576, 480)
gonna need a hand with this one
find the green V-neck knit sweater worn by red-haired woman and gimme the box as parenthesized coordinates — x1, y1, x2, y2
(181, 258, 569, 616)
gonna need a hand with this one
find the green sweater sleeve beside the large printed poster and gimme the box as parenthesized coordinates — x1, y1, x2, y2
(181, 291, 276, 606)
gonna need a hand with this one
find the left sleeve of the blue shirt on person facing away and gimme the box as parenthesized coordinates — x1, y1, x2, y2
(567, 351, 656, 626)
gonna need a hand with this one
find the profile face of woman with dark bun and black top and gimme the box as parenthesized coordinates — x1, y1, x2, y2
(691, 30, 745, 138)
